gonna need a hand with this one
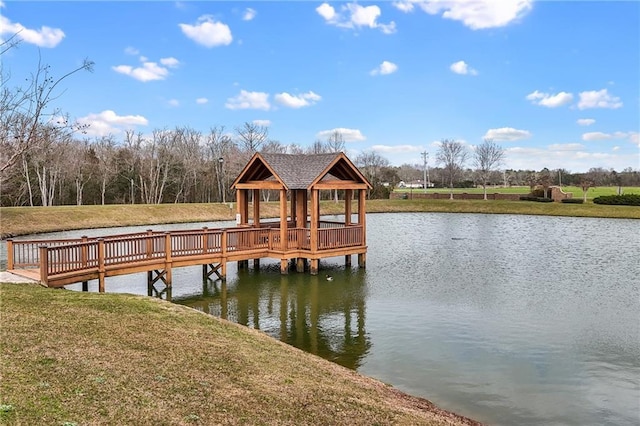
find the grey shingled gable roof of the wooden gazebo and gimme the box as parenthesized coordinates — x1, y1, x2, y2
(232, 152, 371, 190)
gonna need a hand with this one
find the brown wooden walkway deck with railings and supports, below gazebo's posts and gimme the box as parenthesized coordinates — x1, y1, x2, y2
(7, 222, 367, 292)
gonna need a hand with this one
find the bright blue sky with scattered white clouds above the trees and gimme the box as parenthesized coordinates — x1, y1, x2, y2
(0, 0, 640, 172)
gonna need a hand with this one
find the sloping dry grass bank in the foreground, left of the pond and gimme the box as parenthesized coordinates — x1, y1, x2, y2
(0, 284, 477, 426)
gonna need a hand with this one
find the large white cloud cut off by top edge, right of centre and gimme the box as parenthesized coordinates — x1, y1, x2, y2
(393, 0, 533, 30)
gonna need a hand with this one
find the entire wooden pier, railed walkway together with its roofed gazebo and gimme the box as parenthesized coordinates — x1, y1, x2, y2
(7, 153, 371, 292)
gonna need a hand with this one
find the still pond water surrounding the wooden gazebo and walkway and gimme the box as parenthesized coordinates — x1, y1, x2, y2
(0, 213, 640, 425)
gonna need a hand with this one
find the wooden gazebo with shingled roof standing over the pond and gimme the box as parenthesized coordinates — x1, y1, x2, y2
(231, 153, 371, 274)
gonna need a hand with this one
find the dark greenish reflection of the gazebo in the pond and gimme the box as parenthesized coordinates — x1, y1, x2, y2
(173, 267, 371, 370)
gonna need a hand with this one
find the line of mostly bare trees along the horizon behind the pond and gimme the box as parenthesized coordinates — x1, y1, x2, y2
(0, 40, 640, 206)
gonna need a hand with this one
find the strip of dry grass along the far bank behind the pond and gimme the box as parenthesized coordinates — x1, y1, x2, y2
(0, 199, 640, 238)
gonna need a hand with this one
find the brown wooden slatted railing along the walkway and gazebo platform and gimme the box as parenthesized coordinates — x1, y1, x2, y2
(7, 225, 364, 284)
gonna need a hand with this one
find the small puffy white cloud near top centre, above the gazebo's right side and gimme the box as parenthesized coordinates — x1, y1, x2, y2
(316, 3, 396, 34)
